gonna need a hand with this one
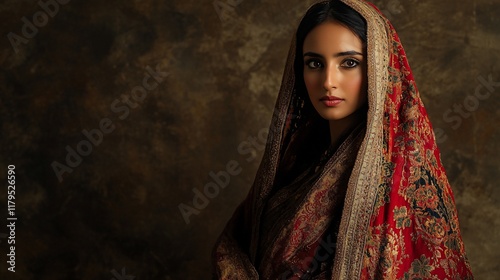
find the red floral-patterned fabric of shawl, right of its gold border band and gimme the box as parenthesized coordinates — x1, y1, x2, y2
(361, 8, 473, 279)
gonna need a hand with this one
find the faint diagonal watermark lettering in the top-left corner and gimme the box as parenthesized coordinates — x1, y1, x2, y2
(7, 0, 70, 53)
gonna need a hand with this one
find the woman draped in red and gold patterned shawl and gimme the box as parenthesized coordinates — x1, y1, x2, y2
(214, 0, 473, 279)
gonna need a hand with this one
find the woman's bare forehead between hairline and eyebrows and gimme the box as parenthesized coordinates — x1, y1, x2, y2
(303, 21, 363, 53)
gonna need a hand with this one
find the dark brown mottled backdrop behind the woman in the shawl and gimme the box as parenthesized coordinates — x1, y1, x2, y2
(0, 0, 500, 280)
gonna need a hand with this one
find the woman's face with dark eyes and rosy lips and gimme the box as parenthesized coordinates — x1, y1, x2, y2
(303, 21, 367, 121)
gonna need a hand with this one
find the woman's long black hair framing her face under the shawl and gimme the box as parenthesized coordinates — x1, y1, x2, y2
(275, 0, 367, 187)
